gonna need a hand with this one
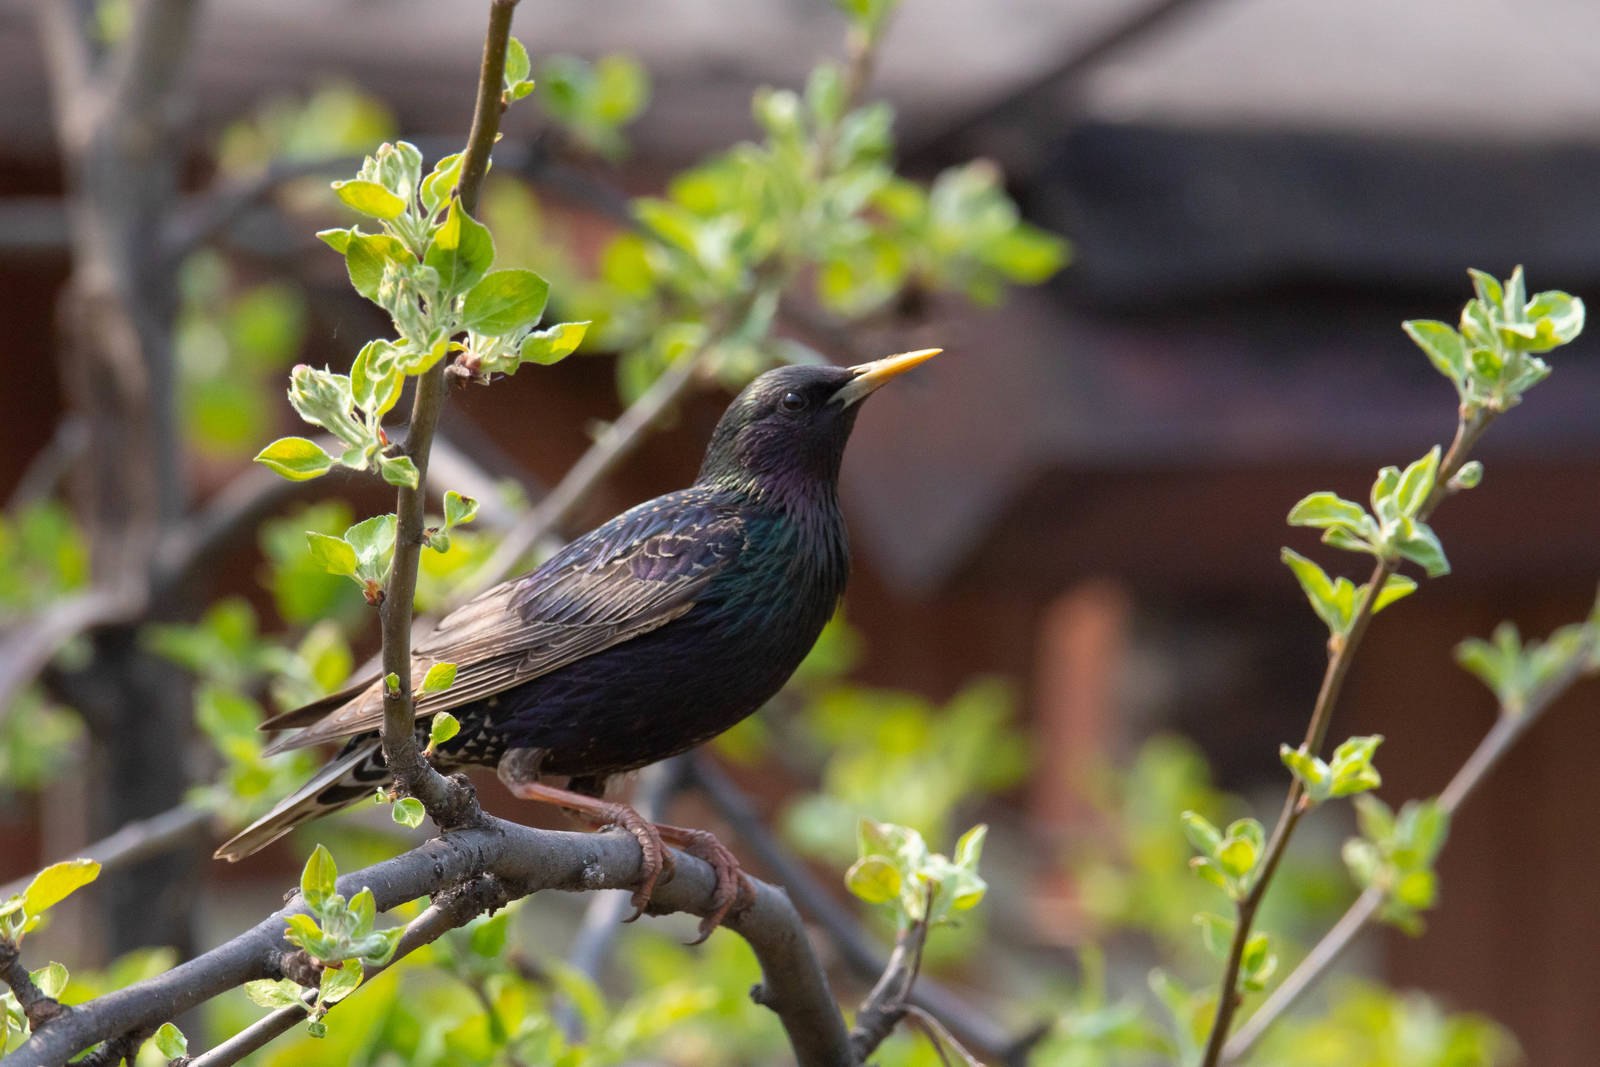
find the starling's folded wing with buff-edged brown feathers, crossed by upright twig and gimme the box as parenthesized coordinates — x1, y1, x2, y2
(262, 494, 744, 752)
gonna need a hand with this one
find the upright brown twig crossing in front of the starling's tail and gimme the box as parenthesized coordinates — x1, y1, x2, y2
(381, 0, 517, 827)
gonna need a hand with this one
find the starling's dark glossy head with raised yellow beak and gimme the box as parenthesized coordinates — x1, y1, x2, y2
(699, 349, 939, 491)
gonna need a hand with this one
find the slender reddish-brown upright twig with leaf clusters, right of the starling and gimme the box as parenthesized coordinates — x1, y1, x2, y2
(1200, 408, 1496, 1067)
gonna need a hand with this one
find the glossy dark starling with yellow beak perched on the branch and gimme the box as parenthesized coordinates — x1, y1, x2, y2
(216, 349, 939, 933)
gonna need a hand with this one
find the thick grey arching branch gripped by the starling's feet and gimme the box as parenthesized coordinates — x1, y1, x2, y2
(5, 817, 851, 1067)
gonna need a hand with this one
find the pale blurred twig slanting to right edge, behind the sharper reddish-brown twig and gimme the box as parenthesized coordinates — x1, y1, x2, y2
(1222, 625, 1600, 1064)
